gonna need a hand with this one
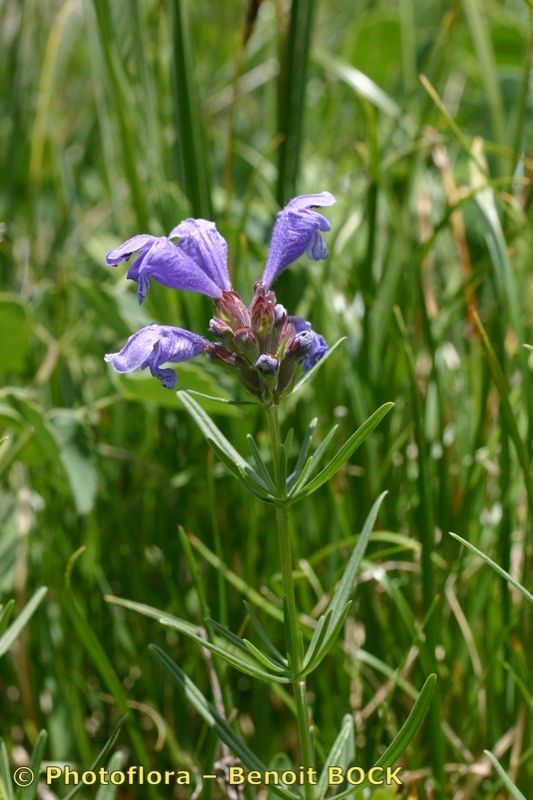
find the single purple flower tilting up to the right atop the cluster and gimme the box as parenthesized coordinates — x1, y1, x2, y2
(263, 192, 335, 287)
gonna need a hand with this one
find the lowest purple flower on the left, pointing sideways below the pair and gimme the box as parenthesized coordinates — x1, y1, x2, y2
(105, 325, 209, 389)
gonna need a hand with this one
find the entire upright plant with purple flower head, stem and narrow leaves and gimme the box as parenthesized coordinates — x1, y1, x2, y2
(105, 192, 435, 800)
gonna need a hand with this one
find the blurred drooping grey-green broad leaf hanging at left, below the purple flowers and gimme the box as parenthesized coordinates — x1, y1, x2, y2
(49, 409, 97, 514)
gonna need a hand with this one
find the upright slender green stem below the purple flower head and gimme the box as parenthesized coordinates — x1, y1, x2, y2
(266, 406, 314, 800)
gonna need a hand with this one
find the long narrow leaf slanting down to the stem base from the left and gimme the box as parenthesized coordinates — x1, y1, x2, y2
(149, 644, 301, 800)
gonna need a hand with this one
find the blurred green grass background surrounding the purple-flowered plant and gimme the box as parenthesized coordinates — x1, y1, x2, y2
(0, 0, 533, 800)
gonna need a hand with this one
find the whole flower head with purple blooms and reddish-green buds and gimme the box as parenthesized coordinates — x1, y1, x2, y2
(105, 192, 335, 394)
